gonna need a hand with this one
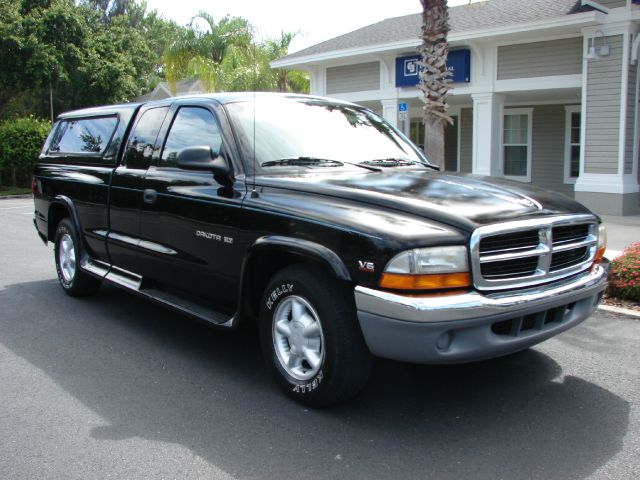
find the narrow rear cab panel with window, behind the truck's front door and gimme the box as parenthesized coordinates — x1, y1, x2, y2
(107, 105, 169, 274)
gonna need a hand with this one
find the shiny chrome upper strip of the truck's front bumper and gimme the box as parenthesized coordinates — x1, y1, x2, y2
(355, 265, 607, 323)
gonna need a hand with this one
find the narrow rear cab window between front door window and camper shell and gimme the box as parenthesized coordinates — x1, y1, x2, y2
(125, 107, 169, 169)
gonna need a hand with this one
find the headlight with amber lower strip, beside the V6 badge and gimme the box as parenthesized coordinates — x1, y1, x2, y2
(380, 246, 471, 290)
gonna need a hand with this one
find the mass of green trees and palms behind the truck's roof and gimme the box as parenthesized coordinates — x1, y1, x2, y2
(0, 0, 308, 119)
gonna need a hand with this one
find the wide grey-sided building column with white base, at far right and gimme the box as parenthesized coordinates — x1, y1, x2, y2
(575, 26, 640, 215)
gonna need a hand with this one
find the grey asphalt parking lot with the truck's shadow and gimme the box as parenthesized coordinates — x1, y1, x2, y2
(0, 200, 640, 480)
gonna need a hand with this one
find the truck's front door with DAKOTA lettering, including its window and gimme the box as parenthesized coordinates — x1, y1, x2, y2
(139, 104, 245, 308)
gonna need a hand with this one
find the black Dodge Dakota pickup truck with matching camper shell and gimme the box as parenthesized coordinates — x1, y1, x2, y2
(34, 93, 607, 406)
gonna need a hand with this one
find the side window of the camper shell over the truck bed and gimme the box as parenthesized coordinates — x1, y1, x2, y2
(49, 117, 118, 154)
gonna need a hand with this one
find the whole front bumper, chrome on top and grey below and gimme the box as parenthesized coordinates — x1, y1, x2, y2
(355, 261, 608, 363)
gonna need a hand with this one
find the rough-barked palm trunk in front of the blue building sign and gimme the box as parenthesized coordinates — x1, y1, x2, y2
(419, 0, 453, 168)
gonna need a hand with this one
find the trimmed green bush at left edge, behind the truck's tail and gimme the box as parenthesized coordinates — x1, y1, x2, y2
(0, 116, 51, 187)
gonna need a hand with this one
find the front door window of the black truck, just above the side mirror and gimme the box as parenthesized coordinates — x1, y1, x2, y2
(160, 107, 222, 167)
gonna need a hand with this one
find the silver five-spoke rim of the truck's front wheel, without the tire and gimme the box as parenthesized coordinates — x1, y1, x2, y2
(272, 295, 324, 380)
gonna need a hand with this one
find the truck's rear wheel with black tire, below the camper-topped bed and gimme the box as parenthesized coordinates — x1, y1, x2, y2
(54, 218, 101, 297)
